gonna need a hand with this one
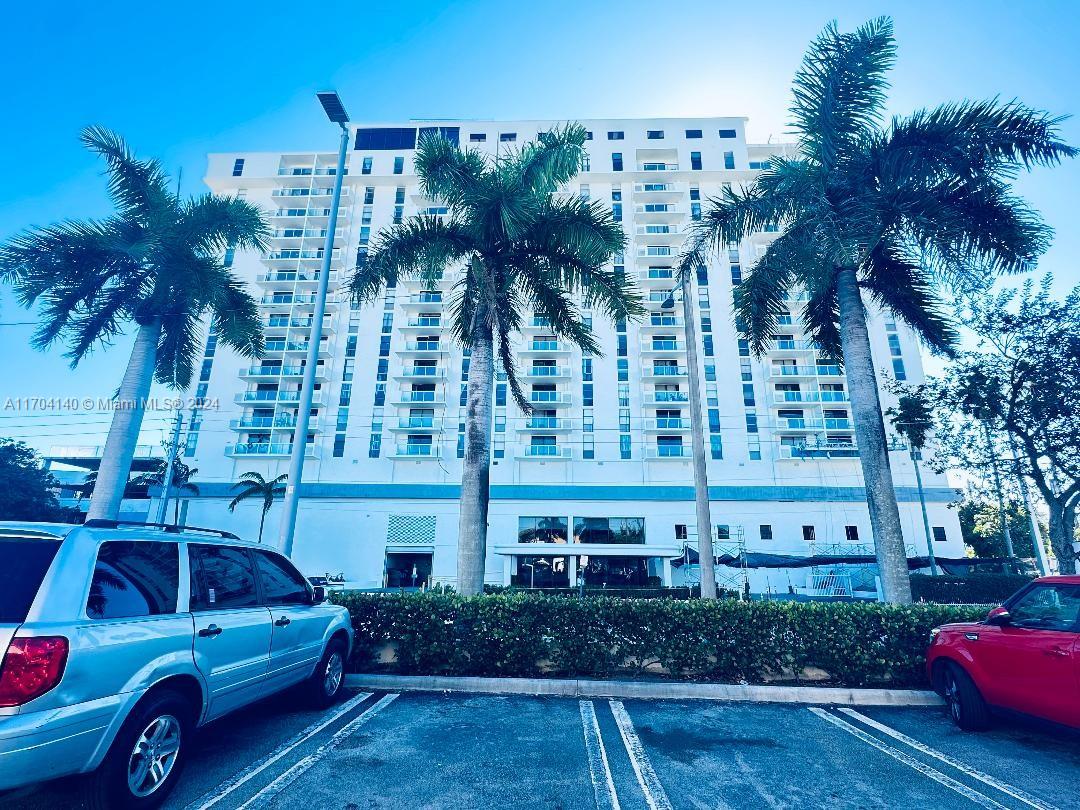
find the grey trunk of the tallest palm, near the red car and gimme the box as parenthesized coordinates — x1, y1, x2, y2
(836, 267, 912, 605)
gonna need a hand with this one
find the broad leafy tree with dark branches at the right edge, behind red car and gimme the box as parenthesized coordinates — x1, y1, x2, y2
(932, 276, 1080, 573)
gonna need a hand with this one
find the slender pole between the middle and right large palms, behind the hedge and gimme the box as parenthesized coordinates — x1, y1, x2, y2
(660, 268, 716, 599)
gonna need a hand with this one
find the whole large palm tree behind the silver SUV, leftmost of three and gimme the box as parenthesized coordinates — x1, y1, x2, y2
(0, 126, 270, 519)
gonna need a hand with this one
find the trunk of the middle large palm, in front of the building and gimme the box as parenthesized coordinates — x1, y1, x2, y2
(458, 308, 495, 596)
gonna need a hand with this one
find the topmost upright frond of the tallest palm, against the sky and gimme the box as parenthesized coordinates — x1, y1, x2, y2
(791, 17, 896, 166)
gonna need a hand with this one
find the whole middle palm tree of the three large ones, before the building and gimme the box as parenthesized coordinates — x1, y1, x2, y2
(351, 124, 643, 595)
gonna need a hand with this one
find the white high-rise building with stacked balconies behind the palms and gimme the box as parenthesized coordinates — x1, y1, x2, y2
(177, 118, 963, 593)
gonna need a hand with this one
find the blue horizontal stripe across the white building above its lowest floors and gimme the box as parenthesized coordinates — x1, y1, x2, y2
(172, 481, 960, 503)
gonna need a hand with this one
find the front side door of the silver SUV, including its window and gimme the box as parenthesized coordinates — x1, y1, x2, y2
(253, 550, 330, 692)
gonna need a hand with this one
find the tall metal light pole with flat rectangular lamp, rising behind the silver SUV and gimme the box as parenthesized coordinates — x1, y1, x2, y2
(279, 92, 349, 557)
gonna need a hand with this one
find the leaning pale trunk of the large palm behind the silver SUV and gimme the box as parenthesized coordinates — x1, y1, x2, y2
(86, 321, 161, 521)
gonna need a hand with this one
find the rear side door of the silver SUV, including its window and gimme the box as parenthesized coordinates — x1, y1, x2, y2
(188, 543, 271, 719)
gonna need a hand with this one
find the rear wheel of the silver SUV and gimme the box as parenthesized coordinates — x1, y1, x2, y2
(86, 691, 192, 810)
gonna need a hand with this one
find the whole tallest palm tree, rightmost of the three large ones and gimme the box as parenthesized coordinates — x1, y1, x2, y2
(684, 18, 1076, 603)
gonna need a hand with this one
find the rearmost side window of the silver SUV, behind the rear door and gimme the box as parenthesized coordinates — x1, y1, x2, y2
(86, 540, 180, 619)
